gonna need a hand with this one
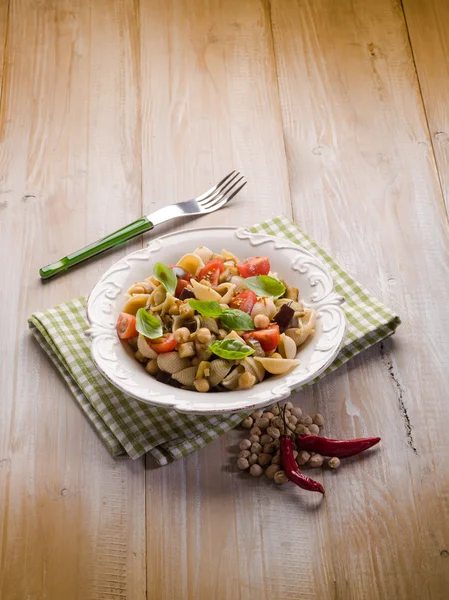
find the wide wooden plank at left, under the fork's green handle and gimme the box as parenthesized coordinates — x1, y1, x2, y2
(0, 0, 146, 600)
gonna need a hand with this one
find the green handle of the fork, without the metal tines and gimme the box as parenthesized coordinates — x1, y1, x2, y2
(39, 217, 154, 279)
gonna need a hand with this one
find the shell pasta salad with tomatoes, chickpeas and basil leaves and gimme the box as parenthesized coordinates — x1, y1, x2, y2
(117, 246, 316, 392)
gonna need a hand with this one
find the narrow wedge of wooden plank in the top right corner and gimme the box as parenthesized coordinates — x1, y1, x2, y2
(402, 0, 449, 207)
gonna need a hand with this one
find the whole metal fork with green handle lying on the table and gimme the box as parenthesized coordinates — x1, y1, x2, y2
(39, 171, 246, 279)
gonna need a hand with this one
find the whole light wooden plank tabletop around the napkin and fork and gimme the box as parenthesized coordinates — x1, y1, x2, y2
(0, 0, 449, 600)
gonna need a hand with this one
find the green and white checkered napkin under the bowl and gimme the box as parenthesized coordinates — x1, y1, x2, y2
(28, 217, 400, 465)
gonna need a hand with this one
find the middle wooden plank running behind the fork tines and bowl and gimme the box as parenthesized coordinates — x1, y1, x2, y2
(140, 0, 291, 600)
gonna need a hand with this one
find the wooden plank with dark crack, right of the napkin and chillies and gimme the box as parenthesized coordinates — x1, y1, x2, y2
(264, 0, 449, 600)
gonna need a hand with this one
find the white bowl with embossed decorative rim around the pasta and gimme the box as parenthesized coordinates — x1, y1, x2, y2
(87, 227, 346, 414)
